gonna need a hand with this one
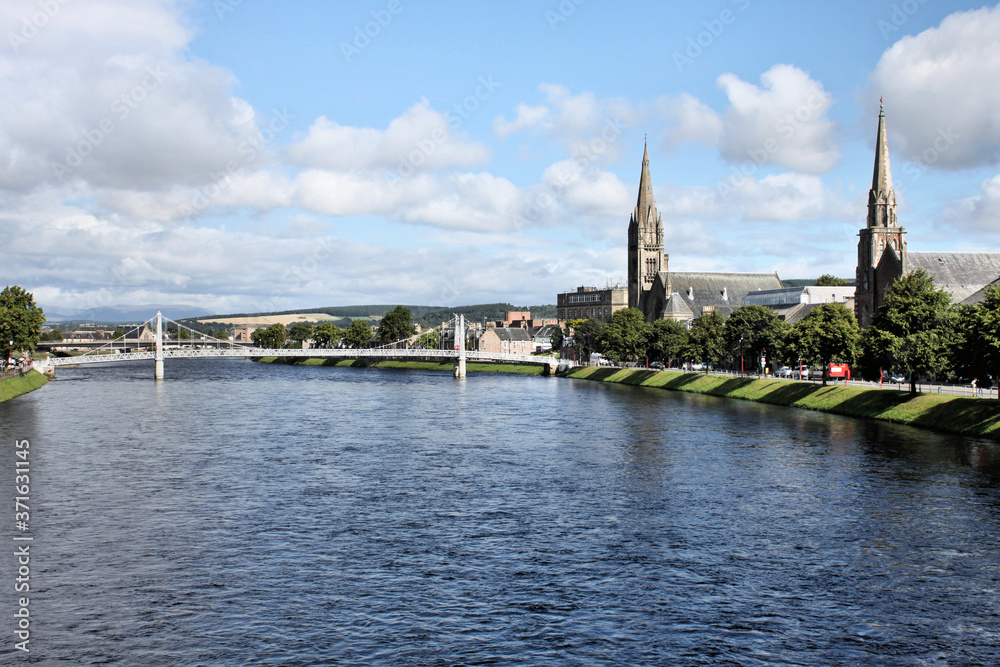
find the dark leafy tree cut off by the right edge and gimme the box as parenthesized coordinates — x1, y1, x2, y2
(953, 285, 1000, 386)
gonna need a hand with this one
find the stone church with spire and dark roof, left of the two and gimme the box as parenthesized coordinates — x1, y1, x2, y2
(628, 147, 782, 322)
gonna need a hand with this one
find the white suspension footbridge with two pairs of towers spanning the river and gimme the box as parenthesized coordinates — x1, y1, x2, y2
(35, 313, 559, 380)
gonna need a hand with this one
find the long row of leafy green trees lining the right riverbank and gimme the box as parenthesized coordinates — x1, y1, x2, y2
(553, 271, 1000, 390)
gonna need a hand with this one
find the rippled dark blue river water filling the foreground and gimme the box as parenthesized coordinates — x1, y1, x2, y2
(0, 360, 1000, 666)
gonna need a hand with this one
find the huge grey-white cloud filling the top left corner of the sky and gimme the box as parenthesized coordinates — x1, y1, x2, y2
(0, 0, 266, 191)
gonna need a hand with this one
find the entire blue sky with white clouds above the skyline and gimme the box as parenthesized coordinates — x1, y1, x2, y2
(0, 0, 1000, 312)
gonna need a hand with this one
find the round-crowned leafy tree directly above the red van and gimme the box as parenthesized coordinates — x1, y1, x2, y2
(788, 303, 861, 384)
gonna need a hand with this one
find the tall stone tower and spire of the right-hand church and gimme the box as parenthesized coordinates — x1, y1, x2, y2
(854, 100, 906, 327)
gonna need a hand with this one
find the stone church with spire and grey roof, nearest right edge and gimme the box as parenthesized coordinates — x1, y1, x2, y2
(854, 102, 1000, 327)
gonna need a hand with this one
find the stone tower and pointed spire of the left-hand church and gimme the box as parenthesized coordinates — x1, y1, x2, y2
(628, 145, 667, 313)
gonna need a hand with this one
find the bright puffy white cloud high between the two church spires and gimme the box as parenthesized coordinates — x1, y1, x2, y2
(658, 65, 840, 174)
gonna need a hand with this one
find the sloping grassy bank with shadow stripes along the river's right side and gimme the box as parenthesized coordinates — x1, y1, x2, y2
(566, 367, 1000, 440)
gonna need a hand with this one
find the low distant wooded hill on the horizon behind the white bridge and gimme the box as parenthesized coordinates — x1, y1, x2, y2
(181, 303, 556, 332)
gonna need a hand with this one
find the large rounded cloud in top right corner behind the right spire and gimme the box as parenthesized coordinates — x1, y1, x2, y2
(864, 7, 1000, 169)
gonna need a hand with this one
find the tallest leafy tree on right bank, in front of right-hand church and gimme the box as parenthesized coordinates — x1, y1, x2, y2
(866, 269, 955, 392)
